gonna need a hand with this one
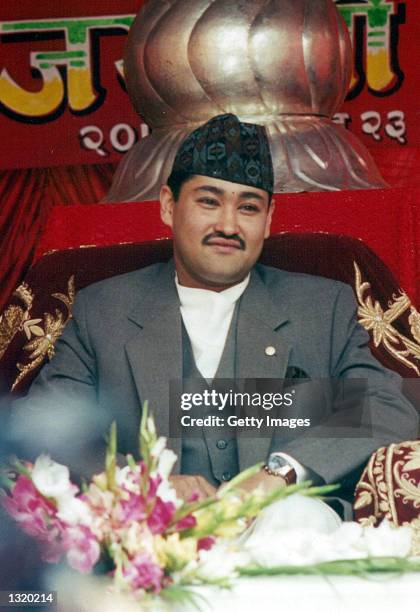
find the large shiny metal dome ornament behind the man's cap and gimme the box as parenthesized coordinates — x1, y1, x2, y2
(106, 0, 386, 202)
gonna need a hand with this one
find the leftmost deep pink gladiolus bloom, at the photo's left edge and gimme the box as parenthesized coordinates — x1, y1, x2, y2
(2, 475, 59, 539)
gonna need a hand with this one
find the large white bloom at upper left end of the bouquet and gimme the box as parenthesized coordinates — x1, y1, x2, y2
(31, 455, 78, 500)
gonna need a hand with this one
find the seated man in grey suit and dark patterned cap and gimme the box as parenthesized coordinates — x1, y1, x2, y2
(11, 115, 417, 516)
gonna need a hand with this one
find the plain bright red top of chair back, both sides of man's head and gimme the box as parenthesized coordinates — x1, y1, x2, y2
(35, 187, 420, 307)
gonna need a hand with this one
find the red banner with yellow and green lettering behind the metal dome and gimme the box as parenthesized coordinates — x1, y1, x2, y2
(0, 0, 420, 169)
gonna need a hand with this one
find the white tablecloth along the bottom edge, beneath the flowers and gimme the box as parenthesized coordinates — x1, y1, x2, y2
(50, 573, 420, 612)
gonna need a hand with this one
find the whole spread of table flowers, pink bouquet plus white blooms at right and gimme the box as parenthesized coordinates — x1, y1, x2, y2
(1, 404, 420, 601)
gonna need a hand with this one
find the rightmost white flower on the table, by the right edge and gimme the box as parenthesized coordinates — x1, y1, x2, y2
(364, 521, 412, 557)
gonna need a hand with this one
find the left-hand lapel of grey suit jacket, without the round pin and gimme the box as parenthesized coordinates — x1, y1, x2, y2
(125, 261, 182, 471)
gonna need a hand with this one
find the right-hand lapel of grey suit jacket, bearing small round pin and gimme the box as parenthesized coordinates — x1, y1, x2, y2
(236, 268, 291, 470)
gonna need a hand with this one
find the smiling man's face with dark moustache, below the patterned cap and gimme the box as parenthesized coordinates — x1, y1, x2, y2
(160, 176, 274, 291)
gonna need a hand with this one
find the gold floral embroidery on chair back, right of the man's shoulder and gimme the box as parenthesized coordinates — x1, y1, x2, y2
(353, 262, 420, 376)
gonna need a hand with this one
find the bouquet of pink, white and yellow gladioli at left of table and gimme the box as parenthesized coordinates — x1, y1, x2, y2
(2, 405, 328, 598)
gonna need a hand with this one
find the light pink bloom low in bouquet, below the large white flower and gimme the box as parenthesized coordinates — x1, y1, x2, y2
(64, 525, 101, 574)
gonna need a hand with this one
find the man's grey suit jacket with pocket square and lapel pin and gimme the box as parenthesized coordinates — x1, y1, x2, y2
(11, 262, 418, 482)
